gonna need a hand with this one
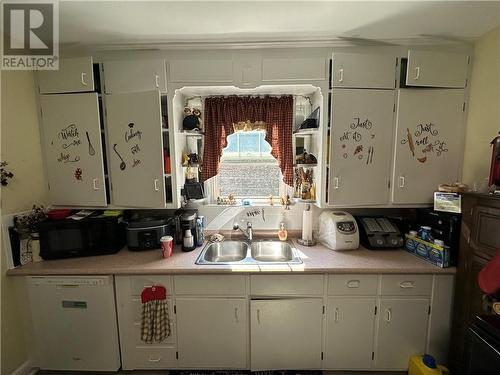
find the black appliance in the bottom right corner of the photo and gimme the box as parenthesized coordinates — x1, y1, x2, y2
(465, 315, 500, 375)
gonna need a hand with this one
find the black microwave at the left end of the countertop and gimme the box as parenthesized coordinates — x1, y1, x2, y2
(39, 216, 126, 260)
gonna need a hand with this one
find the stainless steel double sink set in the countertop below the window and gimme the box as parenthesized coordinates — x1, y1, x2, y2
(196, 240, 302, 265)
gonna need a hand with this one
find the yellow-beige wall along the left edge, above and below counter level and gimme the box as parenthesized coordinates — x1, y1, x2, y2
(0, 71, 47, 375)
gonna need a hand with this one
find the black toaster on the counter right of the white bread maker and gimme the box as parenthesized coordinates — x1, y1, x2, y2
(356, 217, 404, 250)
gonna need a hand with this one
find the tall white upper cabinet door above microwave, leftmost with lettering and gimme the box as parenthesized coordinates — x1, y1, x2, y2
(40, 93, 107, 206)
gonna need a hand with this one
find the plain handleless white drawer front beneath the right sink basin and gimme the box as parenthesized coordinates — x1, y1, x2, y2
(250, 275, 323, 296)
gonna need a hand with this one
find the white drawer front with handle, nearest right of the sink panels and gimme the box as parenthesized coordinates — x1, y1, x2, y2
(328, 275, 378, 296)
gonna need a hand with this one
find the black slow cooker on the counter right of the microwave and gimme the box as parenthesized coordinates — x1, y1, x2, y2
(127, 217, 176, 250)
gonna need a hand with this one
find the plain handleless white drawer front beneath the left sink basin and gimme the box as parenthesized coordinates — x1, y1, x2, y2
(174, 275, 246, 296)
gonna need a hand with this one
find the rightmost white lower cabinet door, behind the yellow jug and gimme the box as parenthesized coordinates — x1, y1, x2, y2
(375, 298, 430, 370)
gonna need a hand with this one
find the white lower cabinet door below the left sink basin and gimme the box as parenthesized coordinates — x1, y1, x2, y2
(176, 297, 248, 369)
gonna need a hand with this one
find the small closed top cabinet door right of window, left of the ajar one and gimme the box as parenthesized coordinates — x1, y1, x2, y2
(332, 52, 396, 89)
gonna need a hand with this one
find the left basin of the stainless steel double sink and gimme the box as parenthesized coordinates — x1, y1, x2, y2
(196, 241, 248, 264)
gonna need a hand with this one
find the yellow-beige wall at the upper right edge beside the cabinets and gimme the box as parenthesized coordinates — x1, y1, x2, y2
(462, 26, 500, 185)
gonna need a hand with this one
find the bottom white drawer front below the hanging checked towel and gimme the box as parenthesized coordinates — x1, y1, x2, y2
(122, 347, 177, 370)
